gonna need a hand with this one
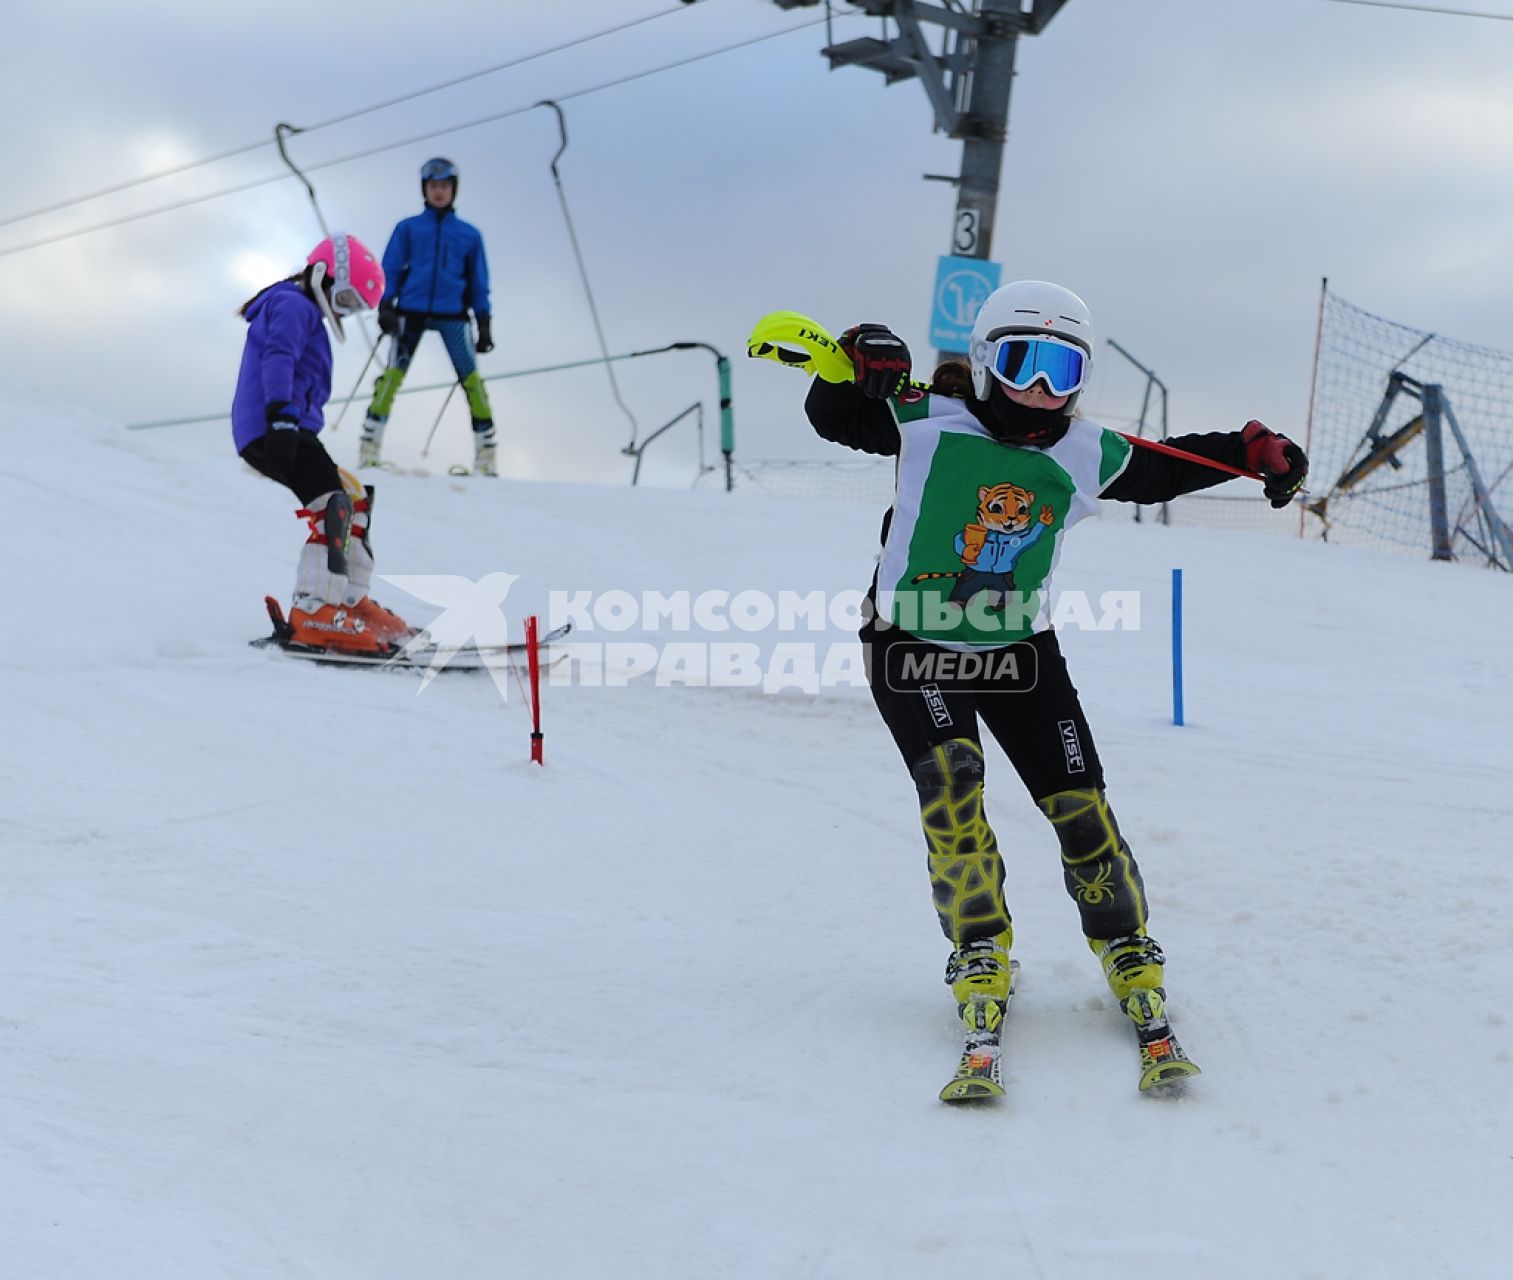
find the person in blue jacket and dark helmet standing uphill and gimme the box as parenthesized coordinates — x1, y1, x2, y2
(357, 156, 498, 475)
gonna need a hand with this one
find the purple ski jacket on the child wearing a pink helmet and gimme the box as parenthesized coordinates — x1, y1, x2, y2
(231, 280, 331, 452)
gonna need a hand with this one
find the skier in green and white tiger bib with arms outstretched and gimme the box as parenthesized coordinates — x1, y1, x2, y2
(805, 280, 1307, 1098)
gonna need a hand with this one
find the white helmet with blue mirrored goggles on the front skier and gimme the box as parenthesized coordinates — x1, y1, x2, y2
(970, 280, 1092, 415)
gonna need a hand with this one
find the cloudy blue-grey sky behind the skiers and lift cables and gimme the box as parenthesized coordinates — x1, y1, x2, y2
(0, 0, 1513, 484)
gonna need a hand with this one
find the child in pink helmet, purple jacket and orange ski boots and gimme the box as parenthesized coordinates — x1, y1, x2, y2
(231, 235, 415, 654)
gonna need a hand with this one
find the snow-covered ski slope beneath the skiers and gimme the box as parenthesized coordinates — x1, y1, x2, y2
(0, 387, 1513, 1280)
